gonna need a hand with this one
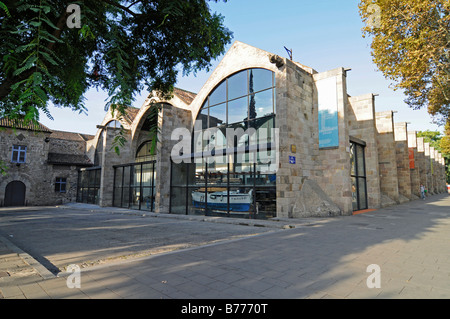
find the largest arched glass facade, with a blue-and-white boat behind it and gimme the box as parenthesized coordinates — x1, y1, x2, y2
(170, 69, 277, 219)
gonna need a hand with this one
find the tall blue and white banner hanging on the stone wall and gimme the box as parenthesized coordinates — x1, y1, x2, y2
(316, 76, 339, 148)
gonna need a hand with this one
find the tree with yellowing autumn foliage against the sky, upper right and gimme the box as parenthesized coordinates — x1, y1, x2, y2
(359, 0, 450, 125)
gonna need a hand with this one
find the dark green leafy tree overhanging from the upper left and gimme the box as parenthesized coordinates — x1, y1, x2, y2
(0, 0, 232, 121)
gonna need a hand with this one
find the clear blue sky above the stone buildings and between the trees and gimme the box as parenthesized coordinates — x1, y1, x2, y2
(40, 0, 443, 134)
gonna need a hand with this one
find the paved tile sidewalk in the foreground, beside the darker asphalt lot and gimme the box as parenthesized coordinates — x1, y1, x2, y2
(0, 194, 450, 299)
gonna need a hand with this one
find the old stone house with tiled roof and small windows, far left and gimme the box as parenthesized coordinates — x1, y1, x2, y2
(0, 119, 92, 206)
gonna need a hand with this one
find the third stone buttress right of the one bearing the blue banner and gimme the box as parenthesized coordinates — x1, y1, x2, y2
(394, 122, 411, 203)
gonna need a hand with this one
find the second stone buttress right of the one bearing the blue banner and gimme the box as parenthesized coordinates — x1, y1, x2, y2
(375, 111, 399, 206)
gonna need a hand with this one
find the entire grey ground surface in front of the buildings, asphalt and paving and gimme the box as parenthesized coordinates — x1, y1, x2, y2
(0, 194, 450, 300)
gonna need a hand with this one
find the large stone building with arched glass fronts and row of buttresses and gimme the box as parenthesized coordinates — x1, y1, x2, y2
(0, 41, 445, 218)
